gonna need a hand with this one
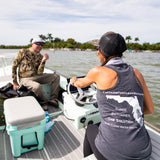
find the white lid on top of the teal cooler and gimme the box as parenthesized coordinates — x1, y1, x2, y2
(4, 96, 45, 126)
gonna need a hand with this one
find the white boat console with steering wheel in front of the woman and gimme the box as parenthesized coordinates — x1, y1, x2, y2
(60, 77, 101, 129)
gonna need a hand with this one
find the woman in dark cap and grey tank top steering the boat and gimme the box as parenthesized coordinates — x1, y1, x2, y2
(71, 32, 154, 160)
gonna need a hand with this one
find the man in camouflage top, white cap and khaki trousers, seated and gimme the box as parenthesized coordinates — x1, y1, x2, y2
(12, 38, 60, 110)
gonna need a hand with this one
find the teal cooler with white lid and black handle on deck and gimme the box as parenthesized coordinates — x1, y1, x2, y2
(4, 96, 46, 157)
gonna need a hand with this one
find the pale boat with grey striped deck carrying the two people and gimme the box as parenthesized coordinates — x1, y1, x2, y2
(0, 56, 160, 160)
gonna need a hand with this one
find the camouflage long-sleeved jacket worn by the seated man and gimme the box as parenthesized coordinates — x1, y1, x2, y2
(12, 48, 45, 83)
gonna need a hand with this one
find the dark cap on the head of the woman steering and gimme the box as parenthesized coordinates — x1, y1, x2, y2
(99, 32, 127, 56)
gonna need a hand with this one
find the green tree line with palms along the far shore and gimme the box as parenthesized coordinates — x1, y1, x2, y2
(0, 33, 160, 51)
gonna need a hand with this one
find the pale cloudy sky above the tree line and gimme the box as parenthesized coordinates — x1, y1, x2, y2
(0, 0, 160, 45)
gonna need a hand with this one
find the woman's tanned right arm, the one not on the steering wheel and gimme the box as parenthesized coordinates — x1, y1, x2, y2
(134, 69, 154, 114)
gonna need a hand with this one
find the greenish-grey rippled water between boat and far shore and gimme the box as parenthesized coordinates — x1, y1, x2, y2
(0, 50, 160, 128)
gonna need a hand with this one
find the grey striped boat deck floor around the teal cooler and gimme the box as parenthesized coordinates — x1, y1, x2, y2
(0, 107, 85, 160)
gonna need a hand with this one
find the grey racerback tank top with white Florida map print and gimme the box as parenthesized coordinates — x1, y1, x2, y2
(95, 57, 152, 160)
